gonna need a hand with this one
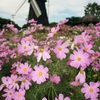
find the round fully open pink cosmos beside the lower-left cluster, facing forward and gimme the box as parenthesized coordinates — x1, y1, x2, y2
(32, 65, 49, 84)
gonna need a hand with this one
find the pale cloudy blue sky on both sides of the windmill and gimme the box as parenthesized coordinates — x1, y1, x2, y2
(0, 0, 100, 26)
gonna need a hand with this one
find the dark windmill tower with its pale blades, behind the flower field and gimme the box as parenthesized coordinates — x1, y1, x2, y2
(12, 0, 49, 26)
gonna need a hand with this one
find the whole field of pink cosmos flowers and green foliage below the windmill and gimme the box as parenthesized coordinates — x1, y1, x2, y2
(0, 19, 100, 100)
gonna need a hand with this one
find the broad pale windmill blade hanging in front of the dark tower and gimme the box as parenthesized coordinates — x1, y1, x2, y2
(30, 0, 42, 17)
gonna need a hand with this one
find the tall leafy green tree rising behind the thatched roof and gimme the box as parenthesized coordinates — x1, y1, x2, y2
(84, 2, 100, 19)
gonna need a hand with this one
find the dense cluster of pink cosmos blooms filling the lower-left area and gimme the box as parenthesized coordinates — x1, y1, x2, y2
(0, 62, 49, 100)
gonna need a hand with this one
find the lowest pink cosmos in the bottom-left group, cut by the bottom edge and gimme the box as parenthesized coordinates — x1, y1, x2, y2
(13, 89, 25, 100)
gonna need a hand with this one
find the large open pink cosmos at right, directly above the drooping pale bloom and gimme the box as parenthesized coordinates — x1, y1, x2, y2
(70, 50, 90, 69)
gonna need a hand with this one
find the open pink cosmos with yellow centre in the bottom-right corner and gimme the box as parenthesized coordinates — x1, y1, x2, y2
(81, 82, 100, 100)
